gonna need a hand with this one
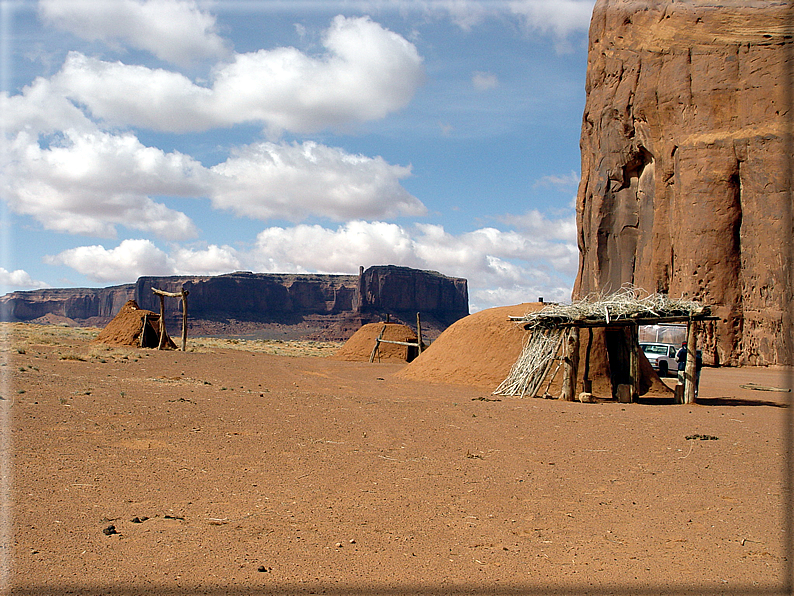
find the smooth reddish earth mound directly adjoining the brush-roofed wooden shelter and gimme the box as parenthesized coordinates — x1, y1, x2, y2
(397, 302, 544, 390)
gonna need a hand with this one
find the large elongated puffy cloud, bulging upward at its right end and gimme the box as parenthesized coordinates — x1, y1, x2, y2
(47, 16, 425, 133)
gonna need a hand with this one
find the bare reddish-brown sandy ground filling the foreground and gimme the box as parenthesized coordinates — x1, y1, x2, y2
(0, 328, 789, 595)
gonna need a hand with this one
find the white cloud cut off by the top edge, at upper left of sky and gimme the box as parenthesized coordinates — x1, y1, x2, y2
(39, 0, 229, 65)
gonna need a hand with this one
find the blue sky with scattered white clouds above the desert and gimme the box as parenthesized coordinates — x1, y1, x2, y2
(0, 0, 594, 311)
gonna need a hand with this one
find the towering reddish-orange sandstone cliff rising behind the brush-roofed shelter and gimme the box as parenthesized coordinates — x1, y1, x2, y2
(574, 0, 794, 364)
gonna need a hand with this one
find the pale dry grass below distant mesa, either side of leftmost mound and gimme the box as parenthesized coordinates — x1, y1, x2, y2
(0, 323, 343, 362)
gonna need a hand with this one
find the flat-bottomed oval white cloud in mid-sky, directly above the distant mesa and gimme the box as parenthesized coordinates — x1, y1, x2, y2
(207, 142, 426, 221)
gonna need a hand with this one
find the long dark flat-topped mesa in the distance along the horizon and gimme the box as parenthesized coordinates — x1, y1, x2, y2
(0, 265, 469, 339)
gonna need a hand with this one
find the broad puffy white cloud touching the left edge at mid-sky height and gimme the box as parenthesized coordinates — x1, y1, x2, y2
(2, 130, 206, 240)
